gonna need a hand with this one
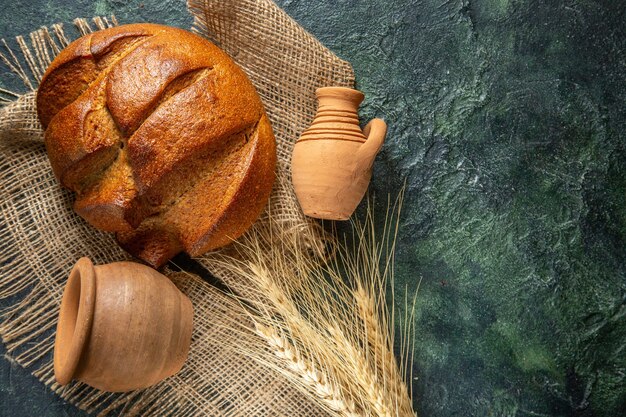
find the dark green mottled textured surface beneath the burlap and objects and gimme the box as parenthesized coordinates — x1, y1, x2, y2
(0, 0, 626, 417)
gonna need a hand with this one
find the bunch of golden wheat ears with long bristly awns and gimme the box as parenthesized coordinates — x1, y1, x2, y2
(206, 195, 415, 417)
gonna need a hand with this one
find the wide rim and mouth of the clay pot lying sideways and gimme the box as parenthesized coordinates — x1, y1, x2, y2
(54, 258, 96, 385)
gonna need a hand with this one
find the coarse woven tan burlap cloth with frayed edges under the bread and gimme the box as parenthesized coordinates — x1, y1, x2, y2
(0, 0, 353, 416)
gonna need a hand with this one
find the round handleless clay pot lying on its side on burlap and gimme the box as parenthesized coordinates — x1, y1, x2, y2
(54, 258, 193, 392)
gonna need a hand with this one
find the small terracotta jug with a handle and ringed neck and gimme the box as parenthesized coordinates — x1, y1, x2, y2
(291, 87, 387, 220)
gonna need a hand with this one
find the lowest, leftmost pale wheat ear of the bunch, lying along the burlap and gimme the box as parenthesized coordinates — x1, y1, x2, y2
(255, 323, 362, 417)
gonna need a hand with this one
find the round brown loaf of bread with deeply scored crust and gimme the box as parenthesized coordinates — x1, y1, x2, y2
(37, 24, 276, 267)
